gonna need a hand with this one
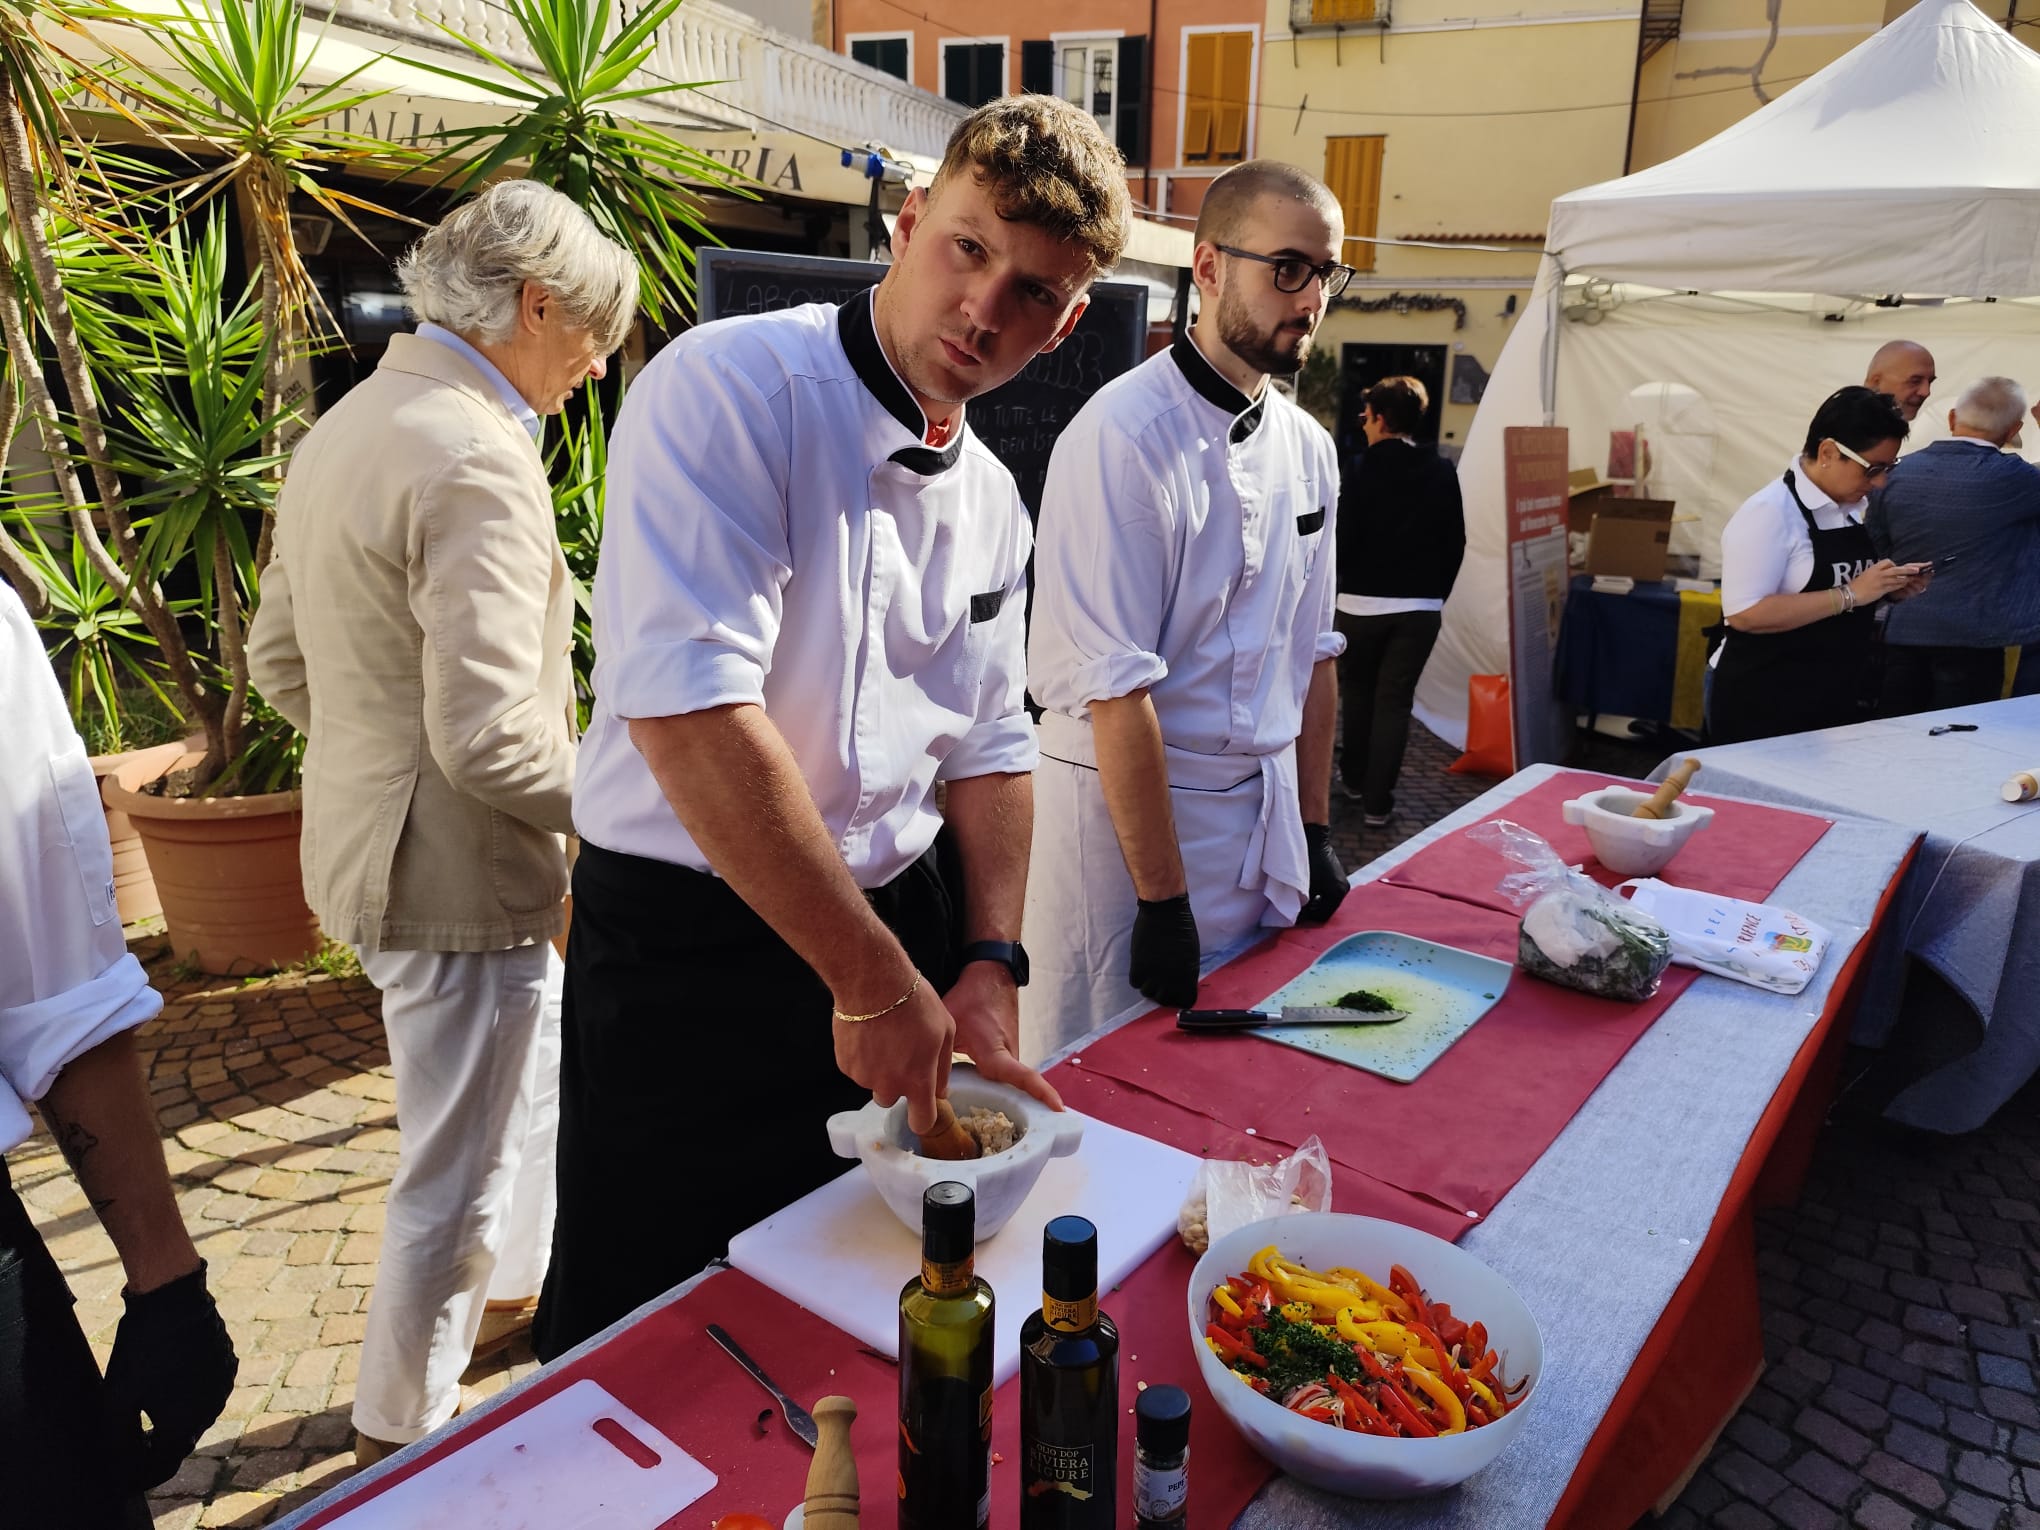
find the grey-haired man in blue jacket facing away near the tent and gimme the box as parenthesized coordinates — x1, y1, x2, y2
(1869, 377, 2040, 716)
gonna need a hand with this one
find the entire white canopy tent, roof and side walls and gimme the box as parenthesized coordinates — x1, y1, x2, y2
(1418, 0, 2040, 763)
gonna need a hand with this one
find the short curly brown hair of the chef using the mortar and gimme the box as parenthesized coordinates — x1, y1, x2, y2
(928, 96, 1132, 271)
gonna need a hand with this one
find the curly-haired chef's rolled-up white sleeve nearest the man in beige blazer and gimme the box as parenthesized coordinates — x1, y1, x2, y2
(596, 341, 792, 718)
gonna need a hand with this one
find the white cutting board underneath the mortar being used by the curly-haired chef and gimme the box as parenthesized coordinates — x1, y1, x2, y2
(730, 1118, 1202, 1385)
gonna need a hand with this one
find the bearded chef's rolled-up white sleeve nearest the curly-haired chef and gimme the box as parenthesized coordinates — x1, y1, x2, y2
(1028, 416, 1177, 718)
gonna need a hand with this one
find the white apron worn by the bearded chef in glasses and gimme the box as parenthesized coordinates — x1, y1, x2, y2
(1020, 755, 1289, 1065)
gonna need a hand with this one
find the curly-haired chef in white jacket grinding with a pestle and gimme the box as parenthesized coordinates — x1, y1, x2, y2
(537, 96, 1128, 1359)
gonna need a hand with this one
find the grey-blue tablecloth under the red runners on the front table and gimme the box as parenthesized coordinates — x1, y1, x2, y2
(277, 765, 1914, 1530)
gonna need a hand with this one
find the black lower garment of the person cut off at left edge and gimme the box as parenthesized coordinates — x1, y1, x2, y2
(0, 1161, 149, 1530)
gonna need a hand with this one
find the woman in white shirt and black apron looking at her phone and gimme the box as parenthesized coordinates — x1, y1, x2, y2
(1707, 388, 1930, 745)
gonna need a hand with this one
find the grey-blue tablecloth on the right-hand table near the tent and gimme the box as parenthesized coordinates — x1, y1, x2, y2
(1652, 696, 2040, 1132)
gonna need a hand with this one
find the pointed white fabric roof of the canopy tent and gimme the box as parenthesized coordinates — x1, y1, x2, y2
(1546, 0, 2040, 298)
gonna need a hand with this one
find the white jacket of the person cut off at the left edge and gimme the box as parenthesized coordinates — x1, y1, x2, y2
(0, 581, 163, 1151)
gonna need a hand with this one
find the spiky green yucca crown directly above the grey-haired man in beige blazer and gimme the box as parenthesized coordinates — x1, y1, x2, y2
(406, 0, 753, 324)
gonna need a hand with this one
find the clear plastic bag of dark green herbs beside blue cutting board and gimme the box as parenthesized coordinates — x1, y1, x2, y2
(1467, 818, 1671, 1004)
